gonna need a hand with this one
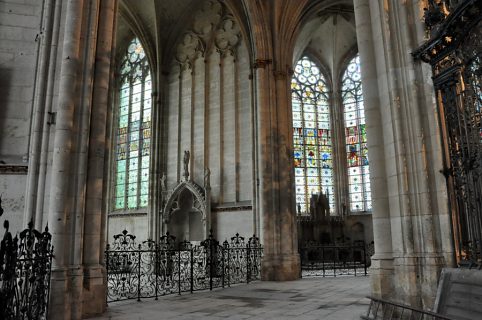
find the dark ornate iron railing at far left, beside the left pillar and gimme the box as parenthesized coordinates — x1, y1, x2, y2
(0, 221, 53, 320)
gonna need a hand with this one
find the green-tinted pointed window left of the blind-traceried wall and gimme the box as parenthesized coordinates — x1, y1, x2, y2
(114, 38, 152, 210)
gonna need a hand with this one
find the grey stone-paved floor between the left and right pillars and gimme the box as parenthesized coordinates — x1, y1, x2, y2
(92, 276, 370, 320)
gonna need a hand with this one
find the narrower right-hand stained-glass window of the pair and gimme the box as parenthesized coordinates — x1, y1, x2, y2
(342, 56, 372, 212)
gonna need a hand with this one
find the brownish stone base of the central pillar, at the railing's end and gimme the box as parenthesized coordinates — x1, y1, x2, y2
(261, 254, 301, 281)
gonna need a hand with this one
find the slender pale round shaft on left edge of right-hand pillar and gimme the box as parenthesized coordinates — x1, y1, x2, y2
(354, 0, 393, 297)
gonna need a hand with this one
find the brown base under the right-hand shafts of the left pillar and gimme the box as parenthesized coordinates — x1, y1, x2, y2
(82, 265, 107, 318)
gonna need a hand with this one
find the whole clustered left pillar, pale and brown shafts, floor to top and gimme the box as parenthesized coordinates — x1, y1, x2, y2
(48, 0, 117, 319)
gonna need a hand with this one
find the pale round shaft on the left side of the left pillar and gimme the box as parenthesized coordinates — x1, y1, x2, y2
(48, 0, 84, 319)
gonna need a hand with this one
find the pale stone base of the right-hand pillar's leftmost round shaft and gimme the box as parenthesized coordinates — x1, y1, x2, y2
(370, 255, 394, 299)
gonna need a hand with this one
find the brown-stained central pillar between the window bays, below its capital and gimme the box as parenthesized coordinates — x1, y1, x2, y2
(255, 60, 300, 281)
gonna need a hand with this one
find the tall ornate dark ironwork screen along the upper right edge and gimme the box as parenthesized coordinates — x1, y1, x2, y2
(413, 0, 482, 266)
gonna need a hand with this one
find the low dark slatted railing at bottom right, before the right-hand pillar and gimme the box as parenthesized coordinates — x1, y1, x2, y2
(360, 297, 455, 320)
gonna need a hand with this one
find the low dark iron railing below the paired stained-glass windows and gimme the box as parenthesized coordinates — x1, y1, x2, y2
(299, 242, 373, 278)
